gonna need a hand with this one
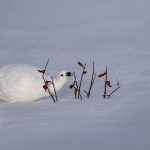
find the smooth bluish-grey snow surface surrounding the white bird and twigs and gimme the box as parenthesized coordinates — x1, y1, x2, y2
(0, 0, 150, 150)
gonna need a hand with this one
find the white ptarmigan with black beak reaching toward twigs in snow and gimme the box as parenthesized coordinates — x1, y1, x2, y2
(0, 64, 71, 102)
